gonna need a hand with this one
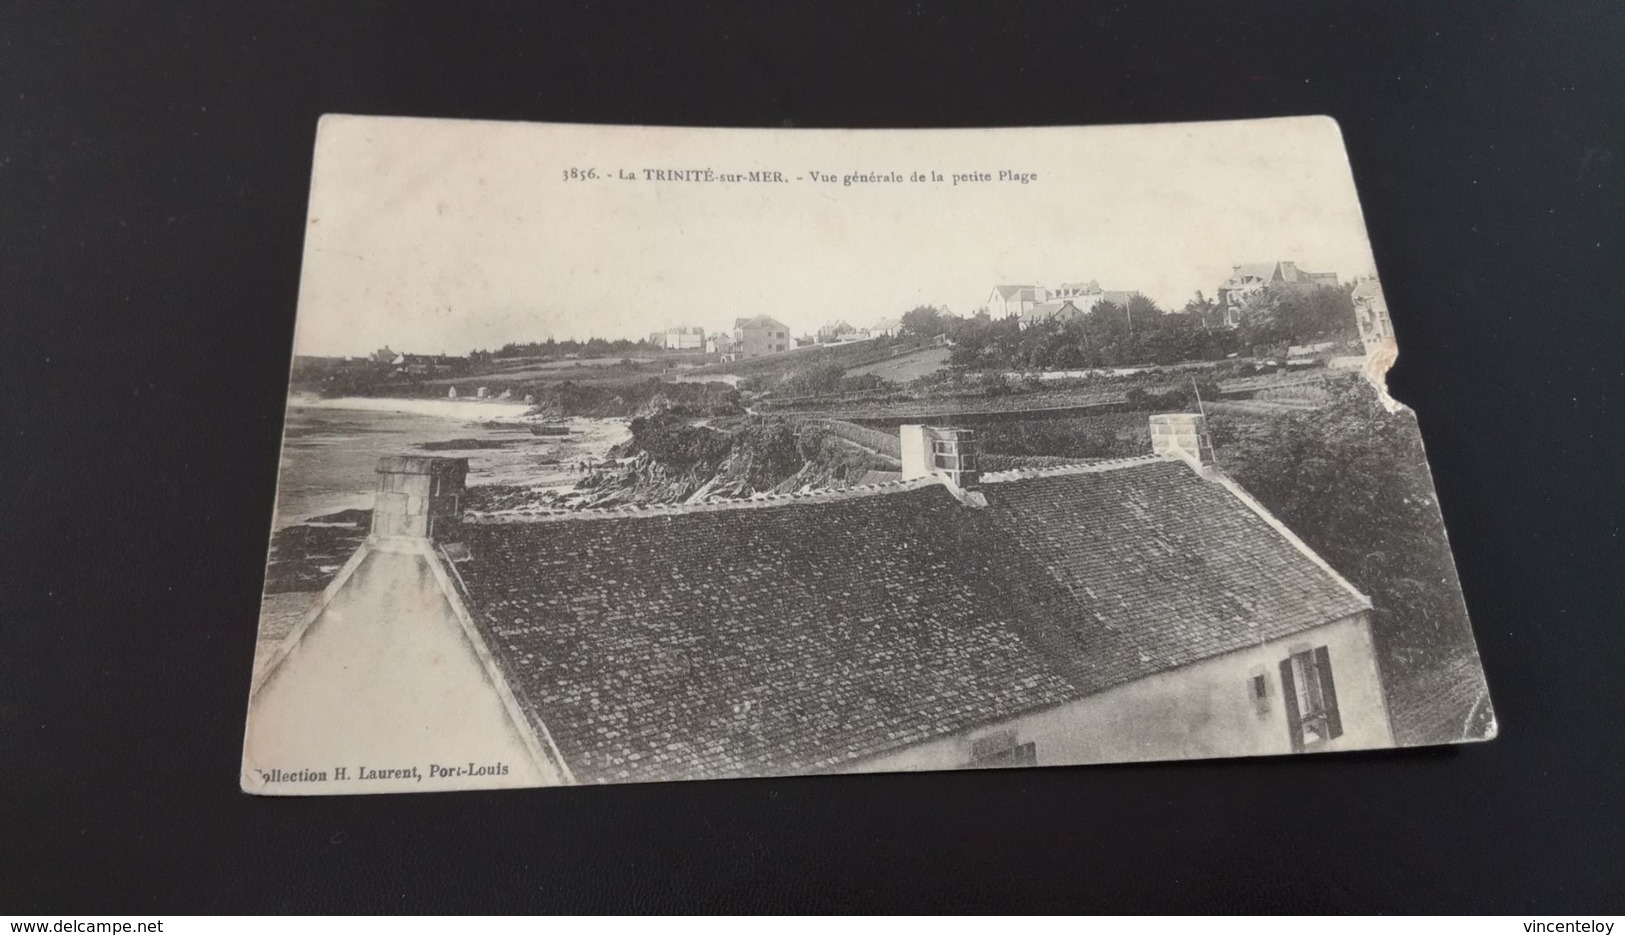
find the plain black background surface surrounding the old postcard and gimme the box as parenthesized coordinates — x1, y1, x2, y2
(0, 0, 1625, 914)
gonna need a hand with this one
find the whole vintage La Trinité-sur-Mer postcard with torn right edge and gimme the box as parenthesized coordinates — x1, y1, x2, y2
(242, 117, 1497, 795)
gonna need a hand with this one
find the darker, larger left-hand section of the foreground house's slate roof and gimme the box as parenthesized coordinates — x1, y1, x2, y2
(457, 485, 1076, 782)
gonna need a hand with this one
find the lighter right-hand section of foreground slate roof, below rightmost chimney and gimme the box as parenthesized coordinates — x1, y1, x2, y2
(982, 459, 1370, 693)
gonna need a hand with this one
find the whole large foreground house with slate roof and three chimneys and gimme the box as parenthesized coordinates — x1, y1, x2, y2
(244, 415, 1393, 794)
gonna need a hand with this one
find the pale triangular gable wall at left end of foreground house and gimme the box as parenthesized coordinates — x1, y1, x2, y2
(242, 545, 559, 795)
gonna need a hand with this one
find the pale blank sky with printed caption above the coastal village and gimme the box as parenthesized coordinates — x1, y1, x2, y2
(294, 115, 1375, 354)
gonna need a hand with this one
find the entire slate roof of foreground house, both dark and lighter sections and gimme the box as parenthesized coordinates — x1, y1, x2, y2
(455, 459, 1368, 782)
